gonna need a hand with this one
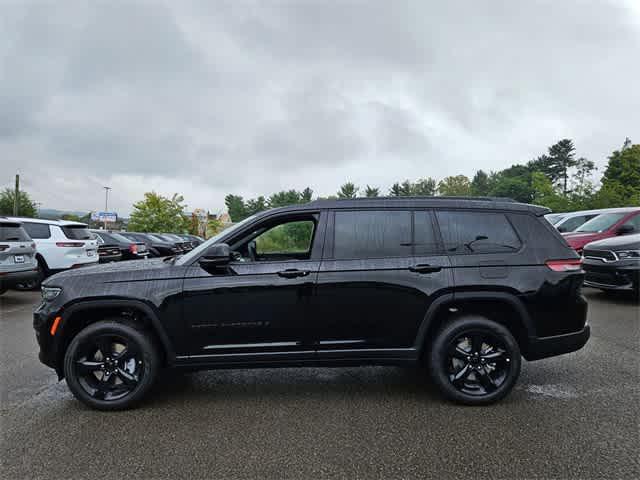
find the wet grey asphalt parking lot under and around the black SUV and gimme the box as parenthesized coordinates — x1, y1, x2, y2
(0, 290, 640, 479)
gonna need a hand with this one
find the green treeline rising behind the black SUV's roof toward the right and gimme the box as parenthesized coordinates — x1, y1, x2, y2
(225, 138, 640, 222)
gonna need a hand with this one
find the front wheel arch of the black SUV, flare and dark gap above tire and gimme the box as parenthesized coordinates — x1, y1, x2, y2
(55, 299, 175, 378)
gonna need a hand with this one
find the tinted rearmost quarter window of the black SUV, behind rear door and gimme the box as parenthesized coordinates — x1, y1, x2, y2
(436, 211, 521, 254)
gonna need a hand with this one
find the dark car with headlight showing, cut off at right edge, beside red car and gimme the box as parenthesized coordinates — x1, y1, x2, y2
(583, 230, 640, 296)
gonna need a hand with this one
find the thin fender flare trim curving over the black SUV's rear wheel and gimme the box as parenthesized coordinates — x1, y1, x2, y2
(414, 291, 536, 352)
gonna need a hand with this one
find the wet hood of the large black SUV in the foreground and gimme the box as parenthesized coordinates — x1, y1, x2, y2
(42, 257, 173, 286)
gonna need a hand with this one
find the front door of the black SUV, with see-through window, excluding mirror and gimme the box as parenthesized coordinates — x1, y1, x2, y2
(181, 212, 324, 362)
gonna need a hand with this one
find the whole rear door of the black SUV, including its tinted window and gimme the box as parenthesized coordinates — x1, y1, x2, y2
(313, 209, 452, 358)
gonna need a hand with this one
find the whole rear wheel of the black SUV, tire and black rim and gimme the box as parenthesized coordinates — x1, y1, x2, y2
(429, 316, 521, 405)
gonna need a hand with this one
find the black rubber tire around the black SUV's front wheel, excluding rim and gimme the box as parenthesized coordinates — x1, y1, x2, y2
(64, 320, 159, 410)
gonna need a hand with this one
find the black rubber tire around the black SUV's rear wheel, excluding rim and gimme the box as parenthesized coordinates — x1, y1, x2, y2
(429, 316, 522, 405)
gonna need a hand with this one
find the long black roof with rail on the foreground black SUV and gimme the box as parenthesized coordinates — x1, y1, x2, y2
(265, 197, 551, 215)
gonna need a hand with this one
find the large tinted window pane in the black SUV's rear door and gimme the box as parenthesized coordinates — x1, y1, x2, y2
(333, 210, 411, 259)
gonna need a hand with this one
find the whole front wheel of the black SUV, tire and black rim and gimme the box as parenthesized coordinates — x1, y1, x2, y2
(63, 319, 160, 410)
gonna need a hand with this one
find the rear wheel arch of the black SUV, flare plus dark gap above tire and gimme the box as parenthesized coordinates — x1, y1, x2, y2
(415, 291, 536, 357)
